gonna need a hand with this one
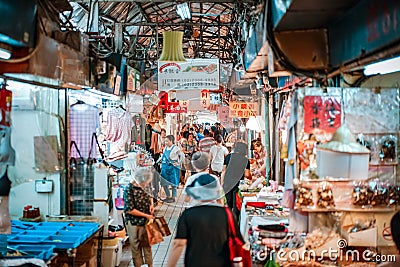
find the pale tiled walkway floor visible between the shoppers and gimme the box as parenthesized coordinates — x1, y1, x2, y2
(119, 189, 184, 267)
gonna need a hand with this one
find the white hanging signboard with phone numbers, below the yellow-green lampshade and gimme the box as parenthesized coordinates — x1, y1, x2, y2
(158, 58, 219, 91)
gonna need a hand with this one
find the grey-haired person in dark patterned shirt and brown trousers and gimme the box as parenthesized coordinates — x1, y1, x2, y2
(124, 167, 154, 267)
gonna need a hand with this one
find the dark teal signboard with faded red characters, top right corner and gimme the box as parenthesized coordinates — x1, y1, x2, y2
(327, 0, 400, 66)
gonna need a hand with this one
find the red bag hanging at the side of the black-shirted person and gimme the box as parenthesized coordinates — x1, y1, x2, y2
(225, 207, 251, 267)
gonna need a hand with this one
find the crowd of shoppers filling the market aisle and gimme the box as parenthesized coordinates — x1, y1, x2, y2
(124, 124, 265, 267)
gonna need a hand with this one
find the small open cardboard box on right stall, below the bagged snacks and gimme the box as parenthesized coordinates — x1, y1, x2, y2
(341, 225, 378, 247)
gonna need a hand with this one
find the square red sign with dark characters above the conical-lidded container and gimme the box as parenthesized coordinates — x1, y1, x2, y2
(304, 96, 342, 133)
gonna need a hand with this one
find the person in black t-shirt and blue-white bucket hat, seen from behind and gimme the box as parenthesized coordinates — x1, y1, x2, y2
(167, 173, 241, 267)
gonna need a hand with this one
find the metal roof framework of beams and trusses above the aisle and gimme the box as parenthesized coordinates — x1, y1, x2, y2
(52, 0, 260, 76)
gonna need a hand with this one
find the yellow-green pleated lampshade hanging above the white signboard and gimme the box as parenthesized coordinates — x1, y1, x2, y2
(159, 31, 186, 62)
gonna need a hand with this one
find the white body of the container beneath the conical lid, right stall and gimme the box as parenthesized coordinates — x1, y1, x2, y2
(317, 148, 369, 179)
